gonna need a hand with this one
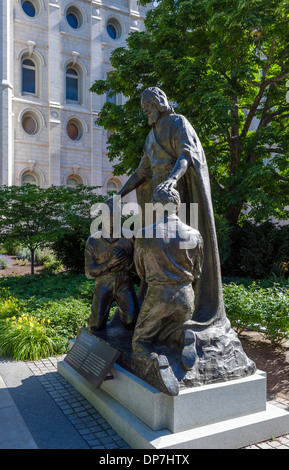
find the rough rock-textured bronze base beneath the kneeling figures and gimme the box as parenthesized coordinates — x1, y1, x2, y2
(78, 313, 257, 395)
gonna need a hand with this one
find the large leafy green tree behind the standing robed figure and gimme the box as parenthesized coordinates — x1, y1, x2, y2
(91, 0, 289, 224)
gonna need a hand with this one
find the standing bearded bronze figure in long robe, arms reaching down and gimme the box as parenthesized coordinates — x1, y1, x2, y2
(118, 87, 225, 328)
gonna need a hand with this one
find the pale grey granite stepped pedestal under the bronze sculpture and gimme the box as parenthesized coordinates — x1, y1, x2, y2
(58, 362, 289, 449)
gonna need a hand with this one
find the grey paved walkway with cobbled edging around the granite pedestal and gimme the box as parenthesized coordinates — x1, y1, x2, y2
(0, 357, 289, 449)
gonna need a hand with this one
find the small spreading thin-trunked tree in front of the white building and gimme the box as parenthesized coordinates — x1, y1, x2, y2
(0, 184, 103, 274)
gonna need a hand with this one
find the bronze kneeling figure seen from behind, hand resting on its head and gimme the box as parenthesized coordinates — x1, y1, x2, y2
(132, 185, 203, 370)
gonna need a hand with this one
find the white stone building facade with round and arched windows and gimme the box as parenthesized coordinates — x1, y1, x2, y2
(0, 0, 146, 194)
